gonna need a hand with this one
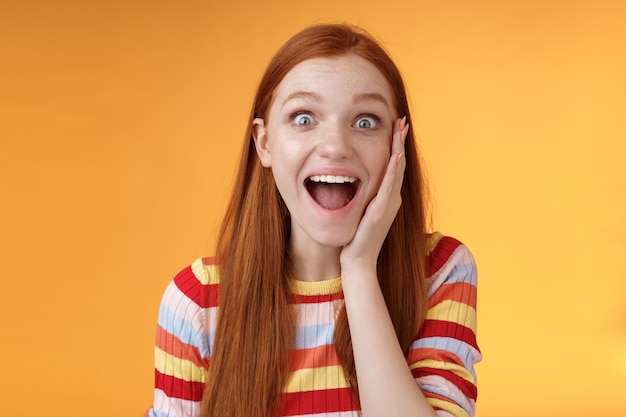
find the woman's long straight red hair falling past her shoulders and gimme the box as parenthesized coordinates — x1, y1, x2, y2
(201, 24, 427, 417)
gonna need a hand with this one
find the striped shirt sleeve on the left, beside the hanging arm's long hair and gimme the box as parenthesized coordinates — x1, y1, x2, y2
(148, 260, 215, 417)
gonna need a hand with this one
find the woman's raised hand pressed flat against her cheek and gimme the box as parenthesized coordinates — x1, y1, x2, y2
(340, 116, 409, 271)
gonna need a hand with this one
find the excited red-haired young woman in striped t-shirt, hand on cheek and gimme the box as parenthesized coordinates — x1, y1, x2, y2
(149, 25, 480, 417)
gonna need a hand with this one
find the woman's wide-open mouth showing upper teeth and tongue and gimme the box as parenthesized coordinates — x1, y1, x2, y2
(304, 175, 361, 210)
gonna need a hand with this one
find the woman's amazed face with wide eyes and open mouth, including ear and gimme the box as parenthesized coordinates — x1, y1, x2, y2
(253, 54, 397, 248)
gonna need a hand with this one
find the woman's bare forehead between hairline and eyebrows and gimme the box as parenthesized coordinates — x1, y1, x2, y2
(274, 54, 395, 103)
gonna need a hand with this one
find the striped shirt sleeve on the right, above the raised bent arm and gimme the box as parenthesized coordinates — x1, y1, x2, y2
(408, 237, 482, 417)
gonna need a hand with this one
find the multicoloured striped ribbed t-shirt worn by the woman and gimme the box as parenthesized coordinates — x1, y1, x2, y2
(149, 233, 481, 417)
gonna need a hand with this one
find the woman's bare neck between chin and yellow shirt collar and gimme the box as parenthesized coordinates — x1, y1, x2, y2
(289, 239, 342, 281)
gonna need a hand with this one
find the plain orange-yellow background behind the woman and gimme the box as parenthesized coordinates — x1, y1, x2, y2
(0, 0, 626, 417)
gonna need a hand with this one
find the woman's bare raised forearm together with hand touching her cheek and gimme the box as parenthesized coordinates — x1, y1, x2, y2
(340, 119, 436, 417)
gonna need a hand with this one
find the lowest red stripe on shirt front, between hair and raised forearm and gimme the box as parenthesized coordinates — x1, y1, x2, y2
(279, 388, 358, 416)
